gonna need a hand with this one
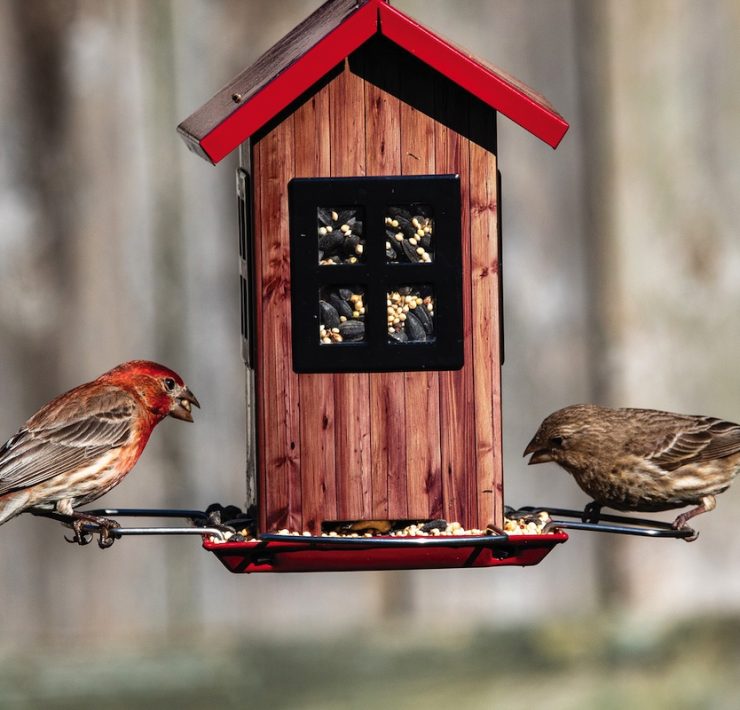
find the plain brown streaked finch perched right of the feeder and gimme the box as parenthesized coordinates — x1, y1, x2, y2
(524, 404, 740, 540)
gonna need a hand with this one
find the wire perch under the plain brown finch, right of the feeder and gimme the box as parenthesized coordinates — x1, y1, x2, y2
(506, 506, 698, 542)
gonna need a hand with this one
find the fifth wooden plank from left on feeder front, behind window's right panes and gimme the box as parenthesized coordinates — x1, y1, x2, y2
(401, 53, 443, 518)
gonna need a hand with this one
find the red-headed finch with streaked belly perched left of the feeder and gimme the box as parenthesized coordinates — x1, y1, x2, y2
(0, 360, 200, 547)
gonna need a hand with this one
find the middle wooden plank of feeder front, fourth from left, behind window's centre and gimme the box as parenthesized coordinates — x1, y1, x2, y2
(365, 48, 408, 519)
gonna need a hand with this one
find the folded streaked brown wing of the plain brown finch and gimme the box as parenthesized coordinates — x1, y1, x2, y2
(647, 417, 740, 471)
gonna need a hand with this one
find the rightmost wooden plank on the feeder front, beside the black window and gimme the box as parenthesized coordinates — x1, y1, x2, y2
(470, 111, 503, 525)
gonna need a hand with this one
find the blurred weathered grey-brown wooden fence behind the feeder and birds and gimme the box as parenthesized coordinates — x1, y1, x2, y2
(0, 0, 740, 709)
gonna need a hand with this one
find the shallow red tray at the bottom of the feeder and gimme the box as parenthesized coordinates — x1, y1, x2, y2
(203, 532, 568, 573)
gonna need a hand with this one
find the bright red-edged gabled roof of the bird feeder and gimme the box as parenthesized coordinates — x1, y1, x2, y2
(177, 0, 568, 164)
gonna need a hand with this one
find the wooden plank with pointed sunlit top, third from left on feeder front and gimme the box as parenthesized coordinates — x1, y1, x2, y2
(329, 63, 372, 520)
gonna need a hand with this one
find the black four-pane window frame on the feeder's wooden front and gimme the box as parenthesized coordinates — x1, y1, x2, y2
(288, 175, 464, 373)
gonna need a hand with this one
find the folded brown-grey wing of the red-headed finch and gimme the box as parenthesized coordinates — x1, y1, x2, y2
(0, 385, 136, 495)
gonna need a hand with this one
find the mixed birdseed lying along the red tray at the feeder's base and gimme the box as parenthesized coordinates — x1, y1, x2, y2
(205, 511, 550, 542)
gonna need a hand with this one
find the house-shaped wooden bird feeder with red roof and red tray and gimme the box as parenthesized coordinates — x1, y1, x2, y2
(178, 0, 568, 572)
